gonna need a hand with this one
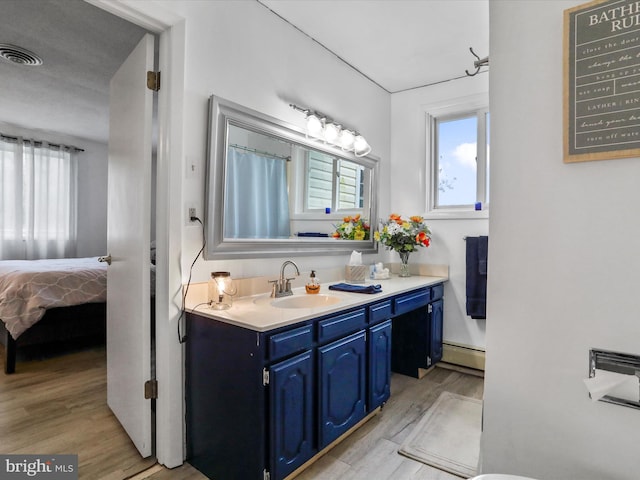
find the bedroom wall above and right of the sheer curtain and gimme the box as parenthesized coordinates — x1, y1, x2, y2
(0, 122, 107, 257)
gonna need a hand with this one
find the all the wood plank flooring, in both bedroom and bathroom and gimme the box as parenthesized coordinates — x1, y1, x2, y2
(0, 347, 483, 480)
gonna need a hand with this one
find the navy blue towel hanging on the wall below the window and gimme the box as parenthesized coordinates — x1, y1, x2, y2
(466, 236, 489, 319)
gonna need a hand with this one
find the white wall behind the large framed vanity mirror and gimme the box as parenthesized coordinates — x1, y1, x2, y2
(168, 1, 390, 282)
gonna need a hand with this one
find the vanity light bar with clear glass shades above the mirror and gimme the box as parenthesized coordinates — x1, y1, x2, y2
(289, 103, 371, 157)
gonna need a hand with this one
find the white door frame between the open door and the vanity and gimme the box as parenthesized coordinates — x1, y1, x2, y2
(85, 0, 186, 468)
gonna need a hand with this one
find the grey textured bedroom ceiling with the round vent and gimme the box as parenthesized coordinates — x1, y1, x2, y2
(0, 0, 145, 142)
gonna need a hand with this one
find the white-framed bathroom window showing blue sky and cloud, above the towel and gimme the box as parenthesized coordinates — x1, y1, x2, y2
(427, 95, 490, 218)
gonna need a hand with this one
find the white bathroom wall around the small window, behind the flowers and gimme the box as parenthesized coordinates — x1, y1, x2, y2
(390, 74, 491, 349)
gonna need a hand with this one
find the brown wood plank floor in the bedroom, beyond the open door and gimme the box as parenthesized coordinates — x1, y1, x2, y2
(0, 347, 155, 480)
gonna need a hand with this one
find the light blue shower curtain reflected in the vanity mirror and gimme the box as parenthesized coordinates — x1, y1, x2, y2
(224, 148, 290, 238)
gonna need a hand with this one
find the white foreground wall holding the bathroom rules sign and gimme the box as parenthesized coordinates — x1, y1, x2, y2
(482, 0, 640, 480)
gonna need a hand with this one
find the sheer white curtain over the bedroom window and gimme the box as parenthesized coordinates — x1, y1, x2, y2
(0, 137, 78, 260)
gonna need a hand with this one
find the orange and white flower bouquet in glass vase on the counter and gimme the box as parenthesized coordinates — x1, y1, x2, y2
(374, 213, 431, 277)
